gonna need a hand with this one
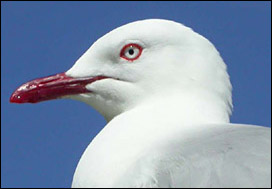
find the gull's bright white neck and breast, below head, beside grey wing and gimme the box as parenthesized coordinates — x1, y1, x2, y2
(74, 91, 228, 187)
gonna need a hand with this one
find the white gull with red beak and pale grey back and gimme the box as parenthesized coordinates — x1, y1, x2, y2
(10, 19, 271, 188)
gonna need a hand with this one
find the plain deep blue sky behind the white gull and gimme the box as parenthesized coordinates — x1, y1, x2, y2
(1, 1, 271, 187)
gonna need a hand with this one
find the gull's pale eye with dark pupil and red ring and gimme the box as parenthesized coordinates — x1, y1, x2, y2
(120, 44, 143, 61)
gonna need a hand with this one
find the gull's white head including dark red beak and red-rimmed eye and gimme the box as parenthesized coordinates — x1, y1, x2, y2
(10, 19, 231, 120)
